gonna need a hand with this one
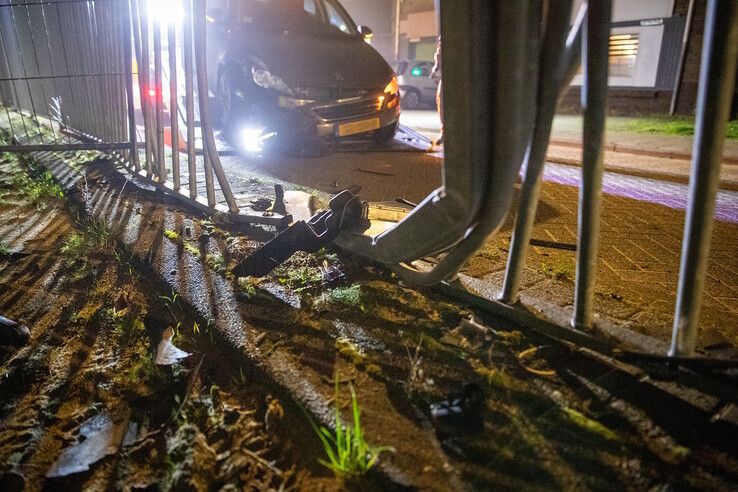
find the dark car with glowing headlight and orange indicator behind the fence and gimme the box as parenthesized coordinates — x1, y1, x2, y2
(207, 0, 400, 150)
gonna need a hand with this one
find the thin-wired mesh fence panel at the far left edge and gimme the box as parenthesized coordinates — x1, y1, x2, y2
(0, 0, 132, 152)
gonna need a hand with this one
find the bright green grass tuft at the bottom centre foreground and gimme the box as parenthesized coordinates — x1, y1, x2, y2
(310, 379, 395, 479)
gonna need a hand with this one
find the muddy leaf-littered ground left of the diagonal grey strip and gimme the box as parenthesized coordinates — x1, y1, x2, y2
(0, 152, 340, 491)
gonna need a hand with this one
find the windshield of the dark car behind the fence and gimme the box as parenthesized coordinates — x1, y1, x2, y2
(230, 0, 359, 36)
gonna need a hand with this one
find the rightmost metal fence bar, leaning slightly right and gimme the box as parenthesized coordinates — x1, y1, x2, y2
(669, 0, 738, 357)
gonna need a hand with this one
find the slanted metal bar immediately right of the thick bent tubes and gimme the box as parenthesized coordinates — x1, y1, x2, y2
(500, 2, 586, 303)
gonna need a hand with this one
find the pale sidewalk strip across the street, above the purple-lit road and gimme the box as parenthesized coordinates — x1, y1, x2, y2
(401, 111, 738, 191)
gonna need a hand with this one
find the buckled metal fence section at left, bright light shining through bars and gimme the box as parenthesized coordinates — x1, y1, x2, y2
(0, 0, 288, 226)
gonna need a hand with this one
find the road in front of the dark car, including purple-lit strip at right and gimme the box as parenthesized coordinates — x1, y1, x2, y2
(218, 110, 738, 223)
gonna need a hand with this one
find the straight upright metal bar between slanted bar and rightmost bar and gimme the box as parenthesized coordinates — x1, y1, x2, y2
(572, 0, 612, 329)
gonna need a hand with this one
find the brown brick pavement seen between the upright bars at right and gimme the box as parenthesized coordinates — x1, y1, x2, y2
(468, 173, 738, 347)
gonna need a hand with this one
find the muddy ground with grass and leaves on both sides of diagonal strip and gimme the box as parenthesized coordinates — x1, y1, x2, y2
(0, 142, 738, 490)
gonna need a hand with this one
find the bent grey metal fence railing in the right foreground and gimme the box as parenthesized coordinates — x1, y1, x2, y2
(339, 0, 738, 358)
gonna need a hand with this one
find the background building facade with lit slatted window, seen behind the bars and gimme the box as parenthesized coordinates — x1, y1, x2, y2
(343, 0, 720, 115)
